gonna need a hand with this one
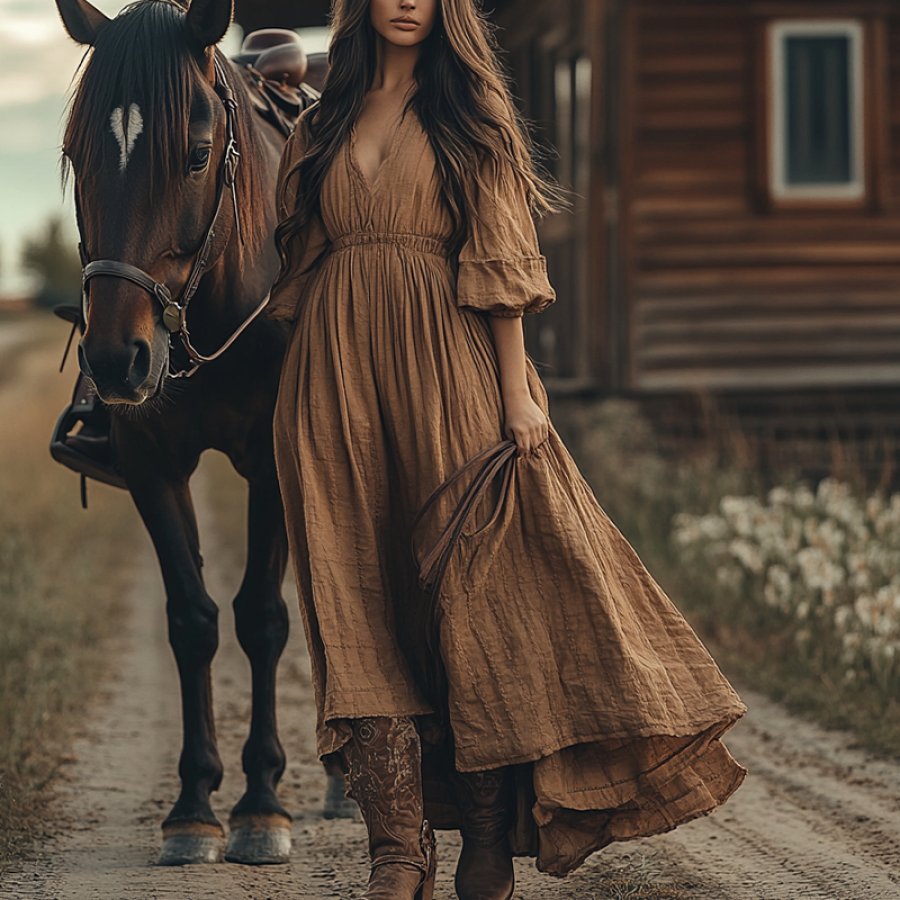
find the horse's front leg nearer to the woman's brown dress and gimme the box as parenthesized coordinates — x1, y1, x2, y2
(225, 469, 291, 865)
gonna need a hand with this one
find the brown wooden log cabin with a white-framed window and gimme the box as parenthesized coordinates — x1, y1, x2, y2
(237, 0, 900, 408)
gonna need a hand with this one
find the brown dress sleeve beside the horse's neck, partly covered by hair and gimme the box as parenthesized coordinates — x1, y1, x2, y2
(267, 107, 330, 322)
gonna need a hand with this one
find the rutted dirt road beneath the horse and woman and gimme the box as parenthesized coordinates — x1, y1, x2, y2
(0, 463, 900, 900)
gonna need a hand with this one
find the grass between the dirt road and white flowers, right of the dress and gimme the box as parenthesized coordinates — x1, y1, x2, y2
(576, 401, 900, 759)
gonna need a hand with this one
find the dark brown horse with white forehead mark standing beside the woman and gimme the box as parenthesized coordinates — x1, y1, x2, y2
(56, 0, 310, 864)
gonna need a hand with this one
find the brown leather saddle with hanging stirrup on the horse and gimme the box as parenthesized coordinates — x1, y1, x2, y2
(50, 28, 319, 509)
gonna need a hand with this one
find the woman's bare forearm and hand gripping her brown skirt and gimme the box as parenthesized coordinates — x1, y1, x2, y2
(489, 315, 550, 456)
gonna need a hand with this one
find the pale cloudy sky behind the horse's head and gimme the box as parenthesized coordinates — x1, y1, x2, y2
(0, 0, 327, 296)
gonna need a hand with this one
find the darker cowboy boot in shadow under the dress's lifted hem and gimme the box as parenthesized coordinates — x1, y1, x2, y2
(453, 767, 516, 900)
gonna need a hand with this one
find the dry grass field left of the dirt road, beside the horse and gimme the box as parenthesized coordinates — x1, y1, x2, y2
(0, 314, 142, 870)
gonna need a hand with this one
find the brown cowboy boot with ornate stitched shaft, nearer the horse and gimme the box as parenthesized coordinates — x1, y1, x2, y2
(342, 716, 435, 900)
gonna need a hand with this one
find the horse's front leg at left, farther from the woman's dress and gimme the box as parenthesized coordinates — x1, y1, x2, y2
(126, 469, 225, 865)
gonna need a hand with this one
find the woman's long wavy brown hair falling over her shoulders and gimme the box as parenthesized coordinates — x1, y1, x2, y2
(275, 0, 569, 274)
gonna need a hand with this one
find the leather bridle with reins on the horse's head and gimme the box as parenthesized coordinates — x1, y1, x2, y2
(71, 56, 269, 378)
